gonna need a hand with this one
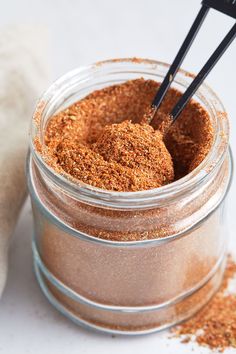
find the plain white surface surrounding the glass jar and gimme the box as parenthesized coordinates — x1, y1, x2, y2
(0, 0, 236, 354)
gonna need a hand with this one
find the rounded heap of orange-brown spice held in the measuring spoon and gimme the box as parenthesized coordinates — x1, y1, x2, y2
(92, 121, 174, 189)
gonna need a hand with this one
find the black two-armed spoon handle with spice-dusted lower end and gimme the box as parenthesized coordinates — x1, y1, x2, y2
(144, 0, 236, 135)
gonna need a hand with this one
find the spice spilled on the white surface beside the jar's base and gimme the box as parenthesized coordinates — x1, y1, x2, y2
(173, 257, 236, 352)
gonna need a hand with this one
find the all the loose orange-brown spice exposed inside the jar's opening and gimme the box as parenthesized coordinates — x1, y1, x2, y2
(41, 79, 213, 191)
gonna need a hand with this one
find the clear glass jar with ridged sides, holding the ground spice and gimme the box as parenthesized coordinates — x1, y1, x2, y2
(27, 59, 232, 334)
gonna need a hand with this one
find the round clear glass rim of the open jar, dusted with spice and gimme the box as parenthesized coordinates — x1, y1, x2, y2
(30, 58, 229, 209)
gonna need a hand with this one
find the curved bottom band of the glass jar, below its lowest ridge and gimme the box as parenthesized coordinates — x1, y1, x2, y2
(34, 242, 226, 335)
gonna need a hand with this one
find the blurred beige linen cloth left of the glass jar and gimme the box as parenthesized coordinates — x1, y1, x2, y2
(0, 26, 48, 296)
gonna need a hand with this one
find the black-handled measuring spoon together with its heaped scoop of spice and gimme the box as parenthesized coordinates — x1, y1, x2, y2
(92, 0, 236, 192)
